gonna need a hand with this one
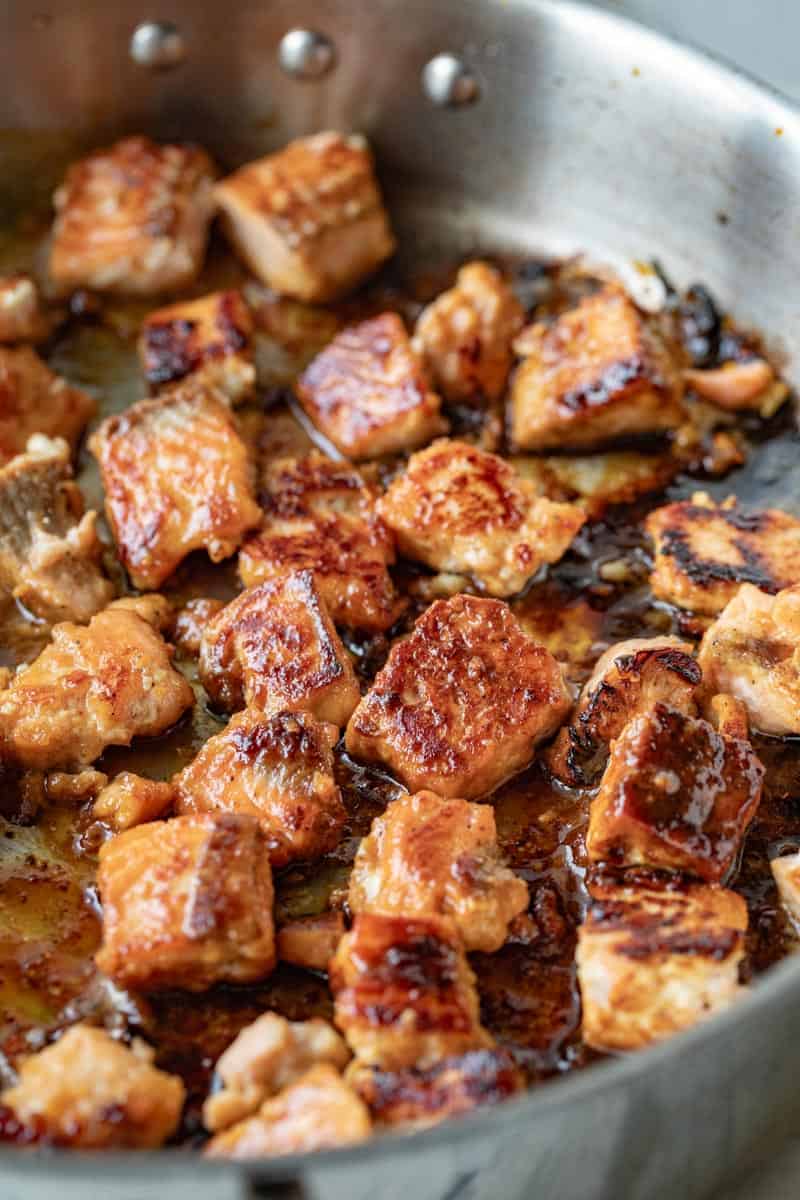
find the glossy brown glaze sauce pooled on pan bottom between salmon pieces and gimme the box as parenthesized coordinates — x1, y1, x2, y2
(0, 208, 800, 1144)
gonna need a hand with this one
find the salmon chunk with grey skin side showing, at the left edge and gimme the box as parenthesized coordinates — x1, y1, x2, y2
(0, 434, 114, 622)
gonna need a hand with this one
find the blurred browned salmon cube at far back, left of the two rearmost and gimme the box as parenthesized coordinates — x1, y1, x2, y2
(50, 137, 213, 295)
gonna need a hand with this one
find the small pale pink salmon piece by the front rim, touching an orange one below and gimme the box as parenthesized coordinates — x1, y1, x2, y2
(203, 1013, 350, 1133)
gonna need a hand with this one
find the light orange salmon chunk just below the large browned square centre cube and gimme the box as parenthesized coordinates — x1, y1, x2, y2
(349, 792, 528, 953)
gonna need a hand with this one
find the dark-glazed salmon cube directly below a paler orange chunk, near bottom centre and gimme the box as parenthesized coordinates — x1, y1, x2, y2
(329, 913, 493, 1070)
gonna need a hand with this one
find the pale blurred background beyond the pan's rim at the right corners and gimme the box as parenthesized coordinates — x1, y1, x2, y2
(596, 0, 800, 1200)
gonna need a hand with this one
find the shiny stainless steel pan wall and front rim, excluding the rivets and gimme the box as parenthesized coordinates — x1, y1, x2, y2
(0, 0, 800, 1200)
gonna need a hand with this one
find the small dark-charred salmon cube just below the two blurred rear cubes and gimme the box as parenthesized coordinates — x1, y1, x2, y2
(139, 292, 255, 404)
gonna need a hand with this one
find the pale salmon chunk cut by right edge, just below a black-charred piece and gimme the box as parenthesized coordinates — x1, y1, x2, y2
(698, 583, 800, 737)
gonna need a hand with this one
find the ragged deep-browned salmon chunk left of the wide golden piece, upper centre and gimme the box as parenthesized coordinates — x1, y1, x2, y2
(239, 452, 403, 634)
